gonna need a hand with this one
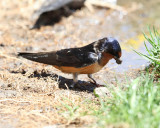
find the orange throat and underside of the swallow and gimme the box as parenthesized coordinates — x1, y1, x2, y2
(53, 53, 113, 74)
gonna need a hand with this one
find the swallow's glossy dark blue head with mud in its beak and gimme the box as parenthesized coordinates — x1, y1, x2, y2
(95, 37, 122, 64)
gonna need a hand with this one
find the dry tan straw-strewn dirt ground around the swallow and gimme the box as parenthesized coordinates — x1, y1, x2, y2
(0, 0, 140, 128)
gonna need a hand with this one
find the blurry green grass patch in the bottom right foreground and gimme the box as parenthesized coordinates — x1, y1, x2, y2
(93, 74, 160, 128)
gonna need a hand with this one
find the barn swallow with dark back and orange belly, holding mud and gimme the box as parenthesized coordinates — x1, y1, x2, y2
(18, 37, 122, 86)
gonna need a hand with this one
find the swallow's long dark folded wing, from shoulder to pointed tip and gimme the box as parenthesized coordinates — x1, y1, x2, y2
(18, 48, 98, 68)
